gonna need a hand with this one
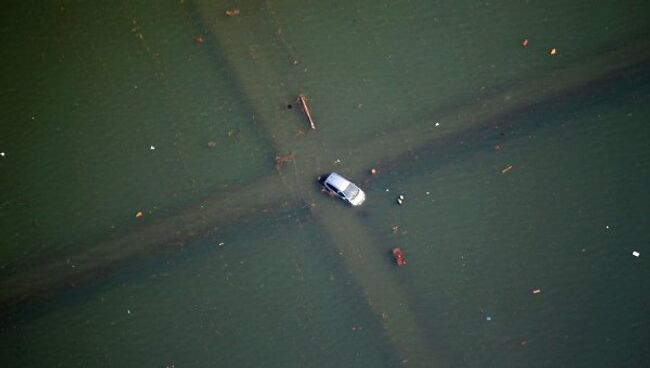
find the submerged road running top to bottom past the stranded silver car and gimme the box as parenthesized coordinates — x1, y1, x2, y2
(191, 1, 441, 367)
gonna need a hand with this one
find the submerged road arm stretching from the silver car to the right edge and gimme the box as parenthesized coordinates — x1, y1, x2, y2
(347, 41, 650, 172)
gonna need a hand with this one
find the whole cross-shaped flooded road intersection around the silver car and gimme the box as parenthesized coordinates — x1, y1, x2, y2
(0, 4, 650, 367)
